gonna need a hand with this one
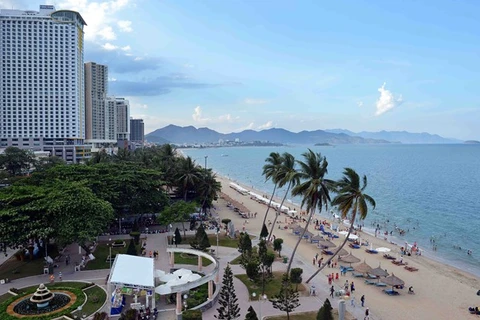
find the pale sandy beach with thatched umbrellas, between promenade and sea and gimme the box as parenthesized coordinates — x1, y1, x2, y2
(218, 176, 480, 320)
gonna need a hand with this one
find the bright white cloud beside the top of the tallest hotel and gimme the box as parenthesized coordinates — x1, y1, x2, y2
(55, 0, 135, 42)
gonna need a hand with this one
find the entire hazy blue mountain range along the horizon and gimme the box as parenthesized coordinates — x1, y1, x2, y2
(145, 124, 463, 144)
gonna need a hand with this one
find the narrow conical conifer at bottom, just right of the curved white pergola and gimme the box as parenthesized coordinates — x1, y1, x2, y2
(215, 264, 240, 320)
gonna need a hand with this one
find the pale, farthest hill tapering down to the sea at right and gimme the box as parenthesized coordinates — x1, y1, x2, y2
(325, 129, 463, 144)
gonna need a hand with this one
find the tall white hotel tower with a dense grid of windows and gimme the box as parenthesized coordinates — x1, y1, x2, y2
(0, 5, 89, 162)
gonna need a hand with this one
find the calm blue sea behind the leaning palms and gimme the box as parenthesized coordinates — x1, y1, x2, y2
(183, 144, 480, 276)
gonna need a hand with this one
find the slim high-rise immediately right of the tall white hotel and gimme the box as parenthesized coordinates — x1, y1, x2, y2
(85, 62, 110, 143)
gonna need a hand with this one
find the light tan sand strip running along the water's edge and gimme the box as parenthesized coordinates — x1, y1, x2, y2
(216, 172, 480, 320)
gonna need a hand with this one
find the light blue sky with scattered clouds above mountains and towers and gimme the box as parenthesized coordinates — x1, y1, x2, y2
(0, 0, 480, 140)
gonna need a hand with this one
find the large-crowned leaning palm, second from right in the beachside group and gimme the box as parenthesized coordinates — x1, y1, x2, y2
(287, 149, 333, 274)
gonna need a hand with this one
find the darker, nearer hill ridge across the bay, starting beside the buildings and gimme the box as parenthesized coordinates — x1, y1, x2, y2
(145, 124, 389, 144)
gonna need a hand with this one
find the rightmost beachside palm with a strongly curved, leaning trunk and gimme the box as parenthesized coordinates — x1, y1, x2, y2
(307, 168, 375, 283)
